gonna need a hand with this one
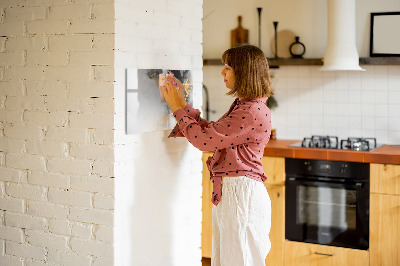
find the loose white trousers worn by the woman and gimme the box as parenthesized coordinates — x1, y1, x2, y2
(211, 176, 271, 266)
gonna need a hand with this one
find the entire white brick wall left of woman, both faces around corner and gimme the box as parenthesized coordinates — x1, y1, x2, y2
(0, 0, 202, 266)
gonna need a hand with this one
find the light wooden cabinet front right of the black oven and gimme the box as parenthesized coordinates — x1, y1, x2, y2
(369, 164, 400, 266)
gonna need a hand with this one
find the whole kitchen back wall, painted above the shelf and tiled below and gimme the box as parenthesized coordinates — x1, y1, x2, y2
(203, 0, 400, 144)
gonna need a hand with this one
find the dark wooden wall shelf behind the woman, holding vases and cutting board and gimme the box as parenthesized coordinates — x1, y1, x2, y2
(203, 57, 400, 68)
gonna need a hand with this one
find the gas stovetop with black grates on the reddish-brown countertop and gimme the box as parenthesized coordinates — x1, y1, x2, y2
(289, 135, 382, 151)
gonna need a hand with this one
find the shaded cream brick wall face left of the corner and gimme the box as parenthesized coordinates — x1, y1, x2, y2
(0, 0, 115, 266)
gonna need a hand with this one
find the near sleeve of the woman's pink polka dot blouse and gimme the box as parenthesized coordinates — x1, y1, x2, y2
(174, 106, 256, 151)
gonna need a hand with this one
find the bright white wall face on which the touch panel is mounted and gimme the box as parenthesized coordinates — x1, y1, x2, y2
(114, 0, 203, 266)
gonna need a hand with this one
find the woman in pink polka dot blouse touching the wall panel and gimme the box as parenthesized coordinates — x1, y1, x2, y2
(161, 45, 272, 266)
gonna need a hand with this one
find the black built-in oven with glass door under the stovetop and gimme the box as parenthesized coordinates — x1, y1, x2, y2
(285, 158, 369, 250)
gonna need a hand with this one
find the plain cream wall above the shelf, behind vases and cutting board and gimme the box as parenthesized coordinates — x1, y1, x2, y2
(203, 0, 400, 58)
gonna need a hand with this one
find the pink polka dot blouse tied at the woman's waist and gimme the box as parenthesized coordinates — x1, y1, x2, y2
(169, 97, 271, 205)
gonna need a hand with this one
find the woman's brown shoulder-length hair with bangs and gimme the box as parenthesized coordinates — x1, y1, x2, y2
(221, 44, 274, 99)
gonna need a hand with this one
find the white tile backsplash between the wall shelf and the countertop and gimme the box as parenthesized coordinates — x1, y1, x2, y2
(204, 65, 400, 144)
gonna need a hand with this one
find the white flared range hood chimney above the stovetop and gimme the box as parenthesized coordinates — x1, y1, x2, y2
(321, 0, 365, 71)
